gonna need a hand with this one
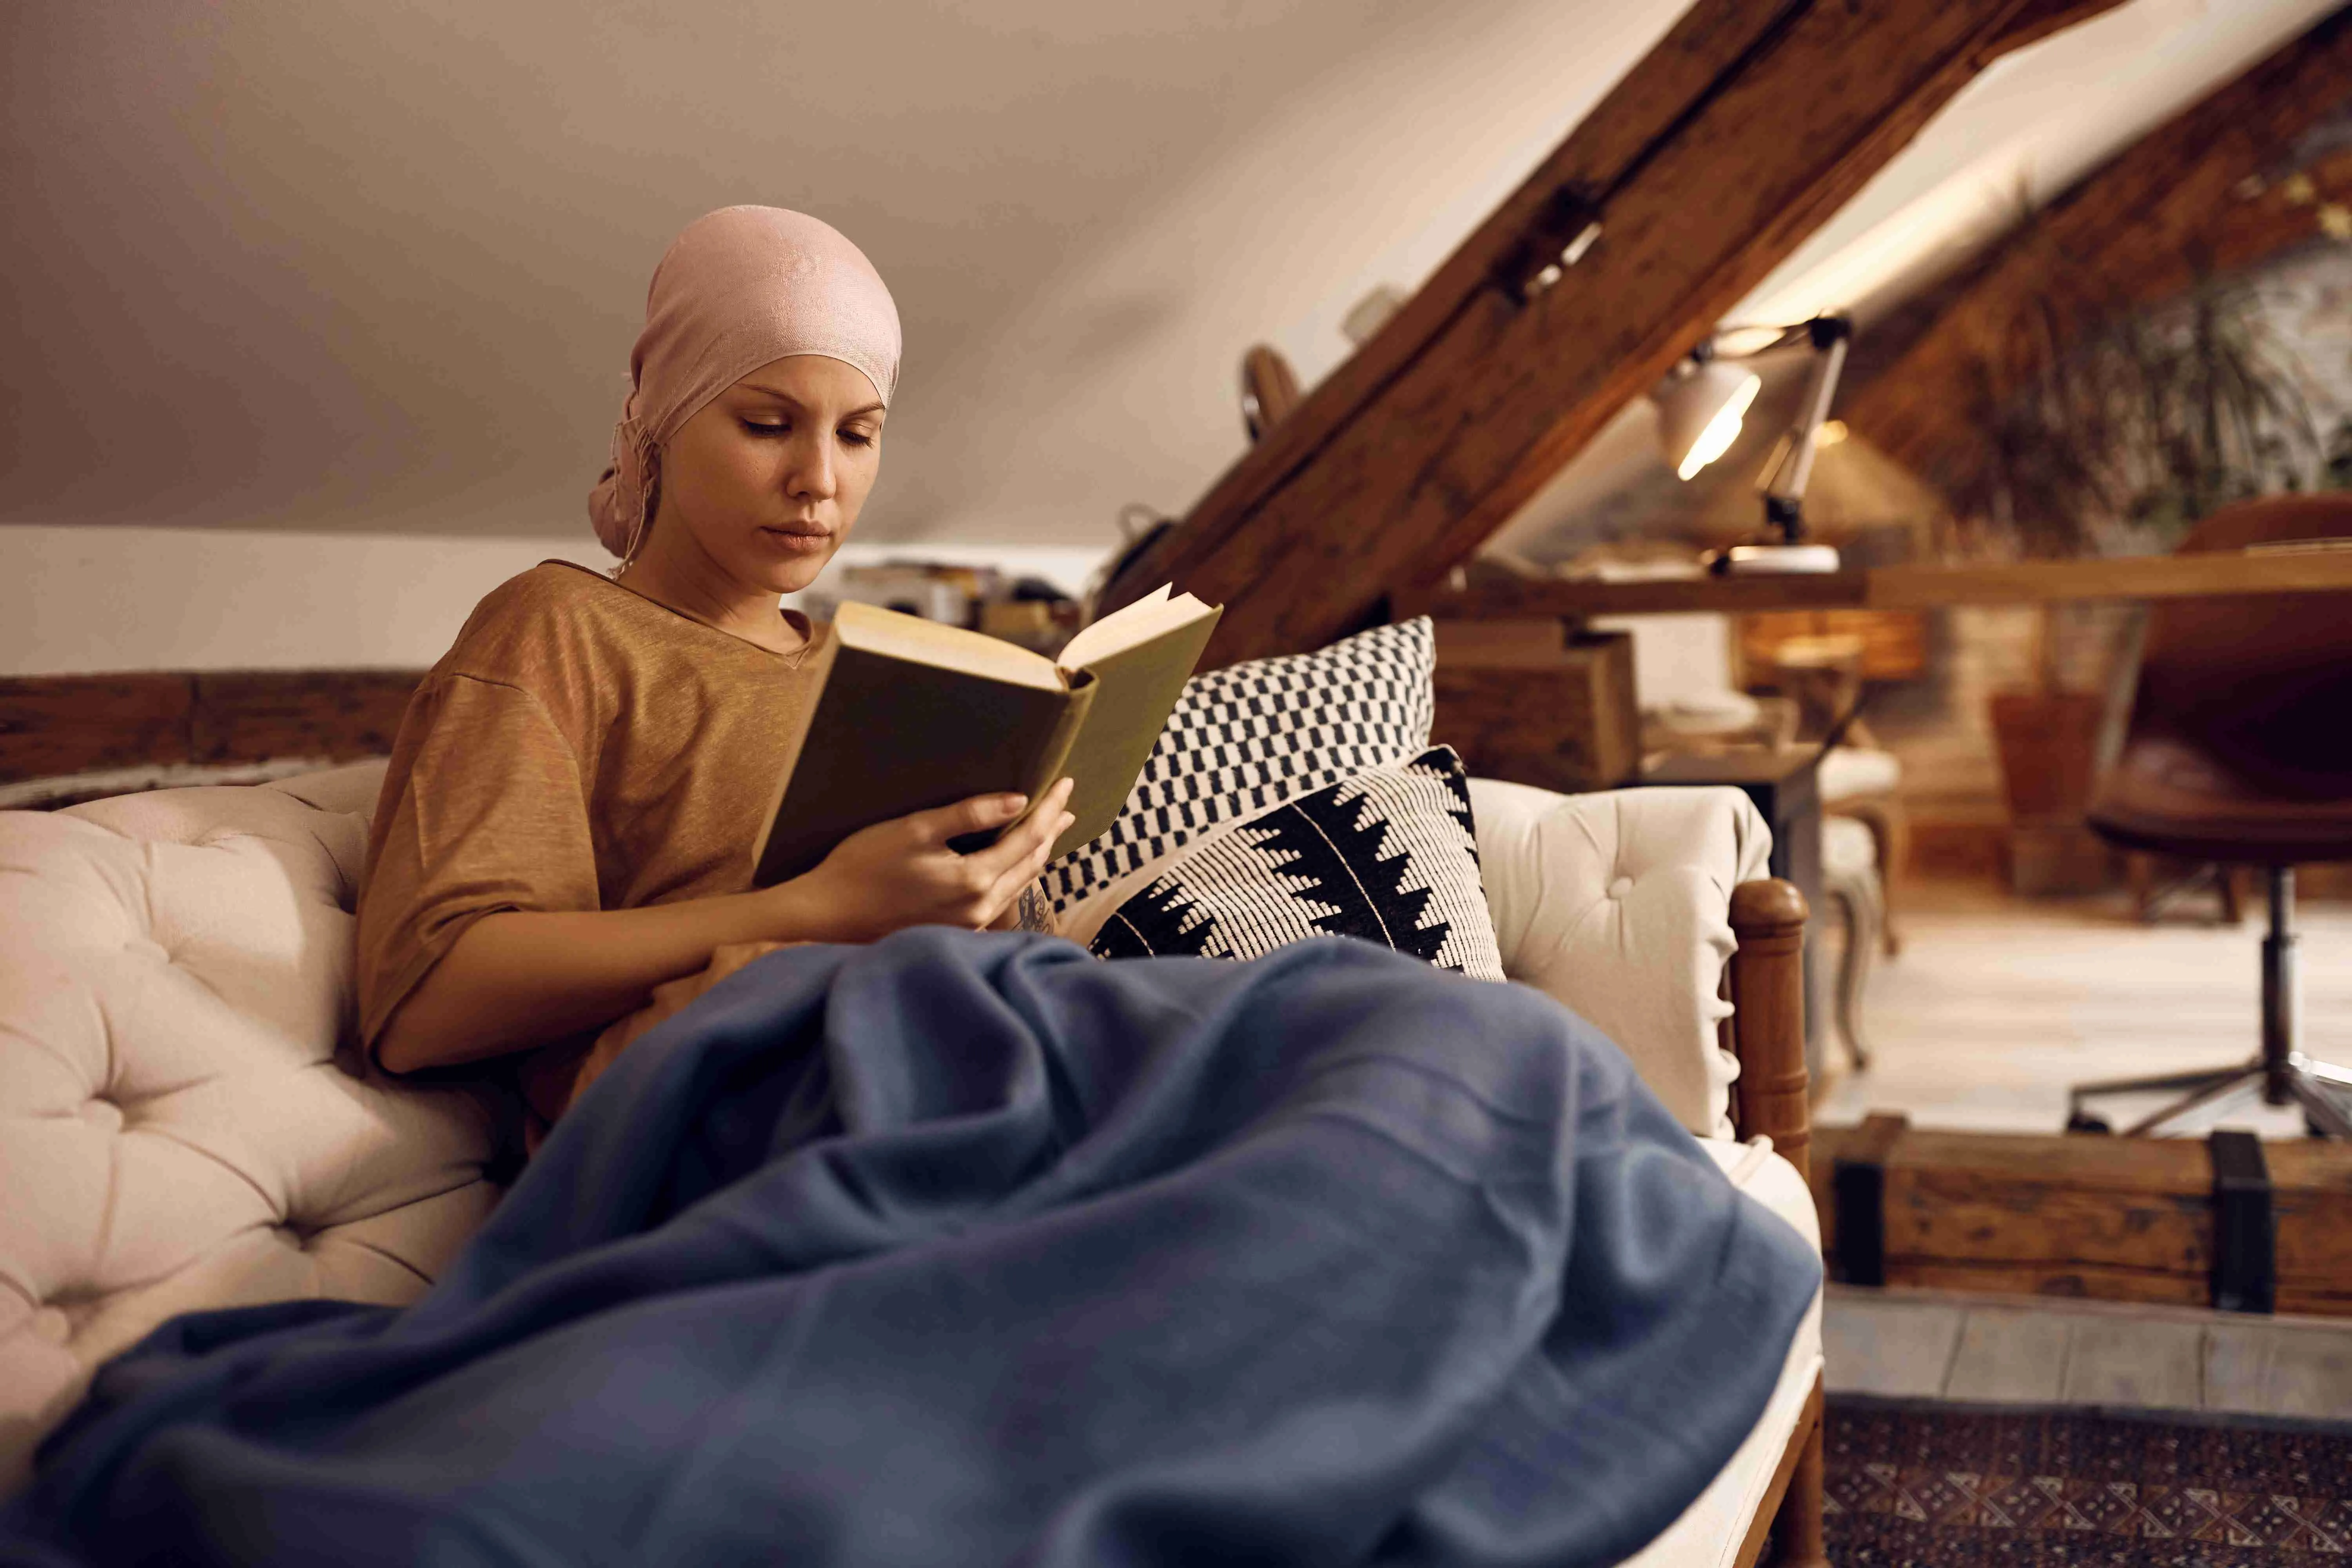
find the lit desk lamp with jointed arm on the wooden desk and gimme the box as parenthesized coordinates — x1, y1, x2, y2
(1651, 315, 1853, 576)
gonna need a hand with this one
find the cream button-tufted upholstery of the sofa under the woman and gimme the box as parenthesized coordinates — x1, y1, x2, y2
(0, 764, 1820, 1568)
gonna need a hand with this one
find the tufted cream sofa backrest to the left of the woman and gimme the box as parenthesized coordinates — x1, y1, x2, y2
(0, 766, 496, 1488)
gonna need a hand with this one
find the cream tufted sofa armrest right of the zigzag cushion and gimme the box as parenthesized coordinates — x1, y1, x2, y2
(1470, 778, 1771, 1138)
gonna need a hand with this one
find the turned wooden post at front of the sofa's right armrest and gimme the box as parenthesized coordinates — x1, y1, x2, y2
(1722, 877, 1813, 1176)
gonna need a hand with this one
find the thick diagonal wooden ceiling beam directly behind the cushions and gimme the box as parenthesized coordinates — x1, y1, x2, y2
(1105, 0, 2136, 665)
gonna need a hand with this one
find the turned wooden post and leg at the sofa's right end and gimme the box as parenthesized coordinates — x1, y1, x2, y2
(1722, 877, 1830, 1568)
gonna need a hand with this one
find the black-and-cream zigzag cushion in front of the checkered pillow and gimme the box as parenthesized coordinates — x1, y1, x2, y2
(1091, 745, 1503, 980)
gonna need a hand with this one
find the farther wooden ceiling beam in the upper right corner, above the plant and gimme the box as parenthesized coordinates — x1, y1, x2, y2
(1839, 7, 2352, 479)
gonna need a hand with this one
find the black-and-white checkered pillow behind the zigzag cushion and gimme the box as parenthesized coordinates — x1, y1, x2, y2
(1044, 618, 1437, 915)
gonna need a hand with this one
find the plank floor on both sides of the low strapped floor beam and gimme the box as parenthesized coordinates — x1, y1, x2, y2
(1813, 884, 2352, 1420)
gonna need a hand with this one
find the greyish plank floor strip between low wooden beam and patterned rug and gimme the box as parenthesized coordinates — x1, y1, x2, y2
(1820, 1286, 2352, 1420)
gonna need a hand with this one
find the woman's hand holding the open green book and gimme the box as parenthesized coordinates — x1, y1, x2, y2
(774, 778, 1077, 943)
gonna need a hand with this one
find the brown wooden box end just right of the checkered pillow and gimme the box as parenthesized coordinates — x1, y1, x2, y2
(1432, 621, 1642, 790)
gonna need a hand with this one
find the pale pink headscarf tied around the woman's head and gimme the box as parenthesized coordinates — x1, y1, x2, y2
(588, 207, 898, 559)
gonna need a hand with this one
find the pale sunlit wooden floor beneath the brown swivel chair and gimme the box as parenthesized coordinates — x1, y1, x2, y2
(1813, 884, 2352, 1138)
